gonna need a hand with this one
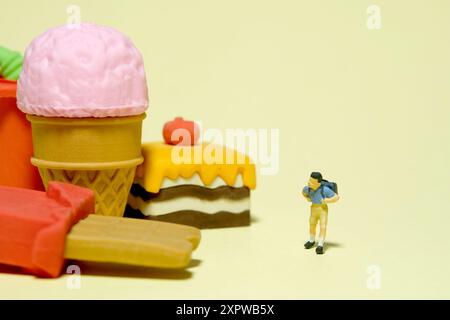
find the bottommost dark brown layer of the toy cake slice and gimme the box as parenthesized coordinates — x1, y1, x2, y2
(125, 205, 250, 229)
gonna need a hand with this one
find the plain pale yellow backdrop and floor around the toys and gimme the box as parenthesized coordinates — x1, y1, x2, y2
(0, 0, 450, 299)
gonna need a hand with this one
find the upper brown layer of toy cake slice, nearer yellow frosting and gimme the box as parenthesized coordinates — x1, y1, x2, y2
(130, 183, 250, 202)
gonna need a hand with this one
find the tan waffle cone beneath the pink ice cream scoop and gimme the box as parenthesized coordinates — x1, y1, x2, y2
(27, 114, 145, 216)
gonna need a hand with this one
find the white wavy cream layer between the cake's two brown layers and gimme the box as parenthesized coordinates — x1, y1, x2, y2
(128, 194, 250, 216)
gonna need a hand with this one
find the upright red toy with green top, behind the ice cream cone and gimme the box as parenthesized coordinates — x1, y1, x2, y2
(0, 79, 44, 190)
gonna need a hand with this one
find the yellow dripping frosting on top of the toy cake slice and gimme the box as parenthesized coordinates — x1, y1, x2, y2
(136, 142, 256, 193)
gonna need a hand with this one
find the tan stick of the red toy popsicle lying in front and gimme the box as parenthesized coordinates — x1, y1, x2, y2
(64, 215, 200, 268)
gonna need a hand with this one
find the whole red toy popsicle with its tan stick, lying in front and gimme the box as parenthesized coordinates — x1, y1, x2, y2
(0, 182, 200, 277)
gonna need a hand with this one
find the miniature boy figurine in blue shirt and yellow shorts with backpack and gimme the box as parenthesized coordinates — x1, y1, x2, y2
(302, 172, 339, 254)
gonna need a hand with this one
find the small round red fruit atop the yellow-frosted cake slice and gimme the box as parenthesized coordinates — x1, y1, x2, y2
(163, 117, 200, 146)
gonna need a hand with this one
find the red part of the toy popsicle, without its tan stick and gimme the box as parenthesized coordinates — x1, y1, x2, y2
(0, 182, 95, 277)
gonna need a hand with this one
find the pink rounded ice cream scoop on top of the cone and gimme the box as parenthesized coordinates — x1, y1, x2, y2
(17, 23, 148, 118)
